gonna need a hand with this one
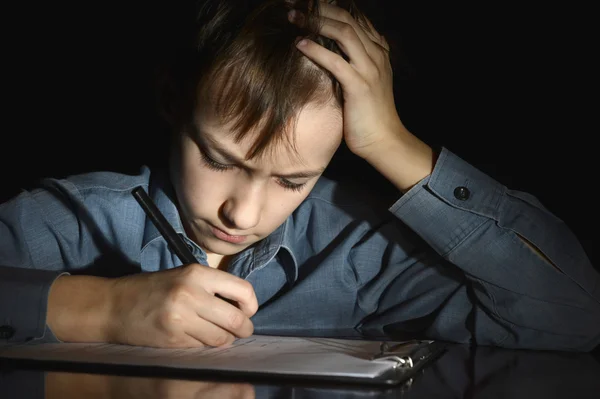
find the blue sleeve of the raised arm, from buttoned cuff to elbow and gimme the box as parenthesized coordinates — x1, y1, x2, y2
(390, 150, 600, 348)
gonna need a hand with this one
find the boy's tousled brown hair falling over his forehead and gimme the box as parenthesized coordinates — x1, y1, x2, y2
(161, 0, 376, 159)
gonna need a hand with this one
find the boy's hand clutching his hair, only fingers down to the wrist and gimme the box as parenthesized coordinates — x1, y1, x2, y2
(289, 0, 406, 158)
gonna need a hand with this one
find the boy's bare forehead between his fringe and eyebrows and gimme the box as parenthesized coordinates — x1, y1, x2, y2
(195, 102, 343, 167)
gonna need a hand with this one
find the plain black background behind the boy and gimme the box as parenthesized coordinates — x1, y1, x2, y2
(0, 0, 598, 263)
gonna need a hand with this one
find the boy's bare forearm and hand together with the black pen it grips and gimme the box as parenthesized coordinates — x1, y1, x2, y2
(46, 188, 258, 348)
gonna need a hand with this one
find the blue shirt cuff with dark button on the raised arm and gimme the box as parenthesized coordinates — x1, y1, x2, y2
(389, 148, 506, 255)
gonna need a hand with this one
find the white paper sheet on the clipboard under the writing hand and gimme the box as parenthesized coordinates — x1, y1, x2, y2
(0, 335, 422, 379)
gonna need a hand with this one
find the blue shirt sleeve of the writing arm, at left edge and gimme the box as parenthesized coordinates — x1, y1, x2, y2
(0, 180, 96, 343)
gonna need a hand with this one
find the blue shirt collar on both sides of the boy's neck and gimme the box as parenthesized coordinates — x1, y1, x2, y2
(142, 171, 298, 283)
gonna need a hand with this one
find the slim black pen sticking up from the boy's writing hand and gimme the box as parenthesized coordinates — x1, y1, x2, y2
(131, 186, 198, 265)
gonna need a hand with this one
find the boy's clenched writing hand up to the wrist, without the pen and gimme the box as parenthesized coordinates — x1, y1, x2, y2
(108, 264, 258, 348)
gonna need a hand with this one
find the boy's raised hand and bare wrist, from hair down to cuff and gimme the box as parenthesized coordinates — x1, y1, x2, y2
(289, 0, 436, 192)
